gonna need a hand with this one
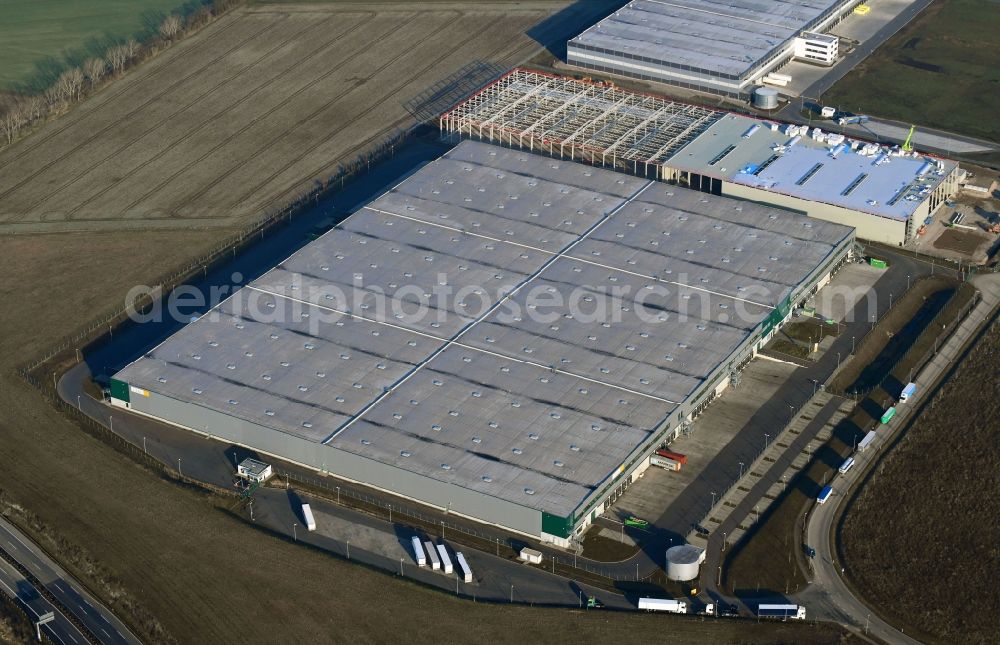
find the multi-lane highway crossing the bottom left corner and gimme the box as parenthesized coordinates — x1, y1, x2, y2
(0, 518, 141, 644)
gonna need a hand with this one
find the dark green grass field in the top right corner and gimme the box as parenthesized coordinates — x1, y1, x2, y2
(823, 0, 1000, 141)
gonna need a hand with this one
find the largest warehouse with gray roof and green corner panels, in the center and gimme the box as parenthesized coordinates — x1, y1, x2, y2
(111, 141, 854, 546)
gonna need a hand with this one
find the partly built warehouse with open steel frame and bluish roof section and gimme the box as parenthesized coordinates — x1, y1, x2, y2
(440, 69, 960, 245)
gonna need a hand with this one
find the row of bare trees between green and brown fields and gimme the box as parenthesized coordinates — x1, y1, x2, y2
(0, 0, 242, 144)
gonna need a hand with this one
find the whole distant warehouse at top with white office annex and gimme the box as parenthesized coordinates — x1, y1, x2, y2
(567, 0, 860, 97)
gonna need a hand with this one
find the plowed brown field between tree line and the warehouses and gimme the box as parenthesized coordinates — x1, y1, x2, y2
(0, 0, 584, 232)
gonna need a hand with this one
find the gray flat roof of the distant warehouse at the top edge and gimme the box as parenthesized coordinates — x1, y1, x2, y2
(570, 0, 844, 77)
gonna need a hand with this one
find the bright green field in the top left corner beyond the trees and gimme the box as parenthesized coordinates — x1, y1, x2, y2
(0, 0, 201, 92)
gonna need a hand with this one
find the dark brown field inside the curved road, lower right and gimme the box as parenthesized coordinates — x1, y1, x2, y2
(841, 323, 1000, 643)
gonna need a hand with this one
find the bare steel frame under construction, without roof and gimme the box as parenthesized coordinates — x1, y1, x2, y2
(440, 68, 724, 177)
